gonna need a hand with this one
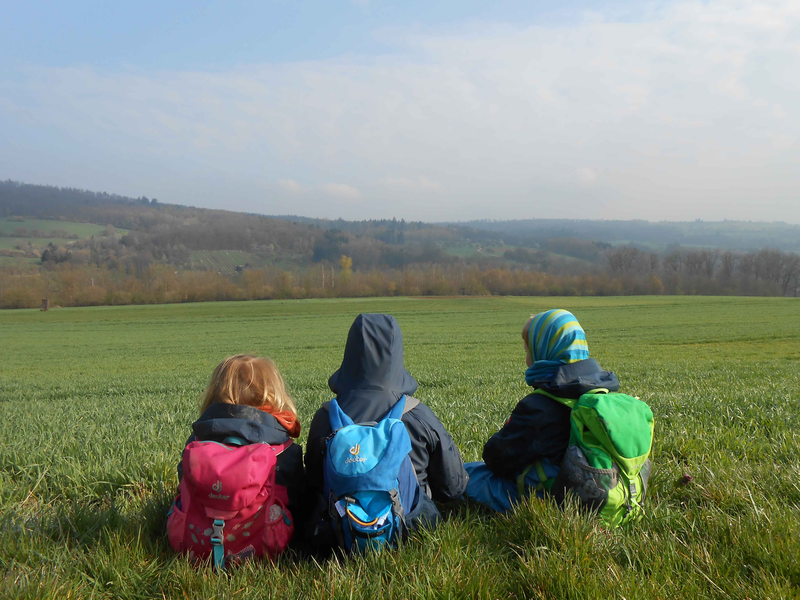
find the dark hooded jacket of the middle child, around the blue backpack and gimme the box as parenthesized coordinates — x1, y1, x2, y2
(306, 314, 467, 502)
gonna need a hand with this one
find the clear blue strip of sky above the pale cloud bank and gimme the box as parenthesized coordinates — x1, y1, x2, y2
(0, 0, 604, 69)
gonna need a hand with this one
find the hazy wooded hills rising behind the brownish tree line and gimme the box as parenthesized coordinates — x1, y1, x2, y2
(0, 181, 800, 275)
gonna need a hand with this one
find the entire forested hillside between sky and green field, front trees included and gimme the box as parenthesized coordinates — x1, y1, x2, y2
(0, 181, 800, 307)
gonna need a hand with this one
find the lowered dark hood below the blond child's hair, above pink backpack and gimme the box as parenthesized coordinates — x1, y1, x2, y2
(192, 402, 289, 445)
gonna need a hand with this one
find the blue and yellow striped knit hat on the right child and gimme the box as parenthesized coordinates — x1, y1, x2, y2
(525, 309, 589, 385)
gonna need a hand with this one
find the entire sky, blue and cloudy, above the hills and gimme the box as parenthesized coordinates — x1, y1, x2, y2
(0, 0, 800, 223)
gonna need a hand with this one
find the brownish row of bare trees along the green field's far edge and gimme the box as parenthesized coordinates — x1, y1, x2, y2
(0, 244, 800, 308)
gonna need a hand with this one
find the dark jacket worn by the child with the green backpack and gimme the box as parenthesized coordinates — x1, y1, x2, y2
(483, 358, 619, 479)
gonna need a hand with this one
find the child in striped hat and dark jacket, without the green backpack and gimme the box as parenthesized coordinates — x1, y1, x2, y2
(465, 309, 619, 512)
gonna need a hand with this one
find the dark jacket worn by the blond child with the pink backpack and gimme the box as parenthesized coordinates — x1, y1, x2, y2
(178, 402, 305, 520)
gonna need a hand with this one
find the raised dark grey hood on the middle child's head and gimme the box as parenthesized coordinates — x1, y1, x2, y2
(328, 314, 417, 423)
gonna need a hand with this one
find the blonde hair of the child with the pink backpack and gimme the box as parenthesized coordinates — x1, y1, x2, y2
(200, 354, 297, 416)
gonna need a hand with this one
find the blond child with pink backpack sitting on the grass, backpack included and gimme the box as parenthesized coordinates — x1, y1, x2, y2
(168, 355, 305, 566)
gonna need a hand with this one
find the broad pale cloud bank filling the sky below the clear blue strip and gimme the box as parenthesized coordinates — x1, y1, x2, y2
(0, 0, 800, 221)
